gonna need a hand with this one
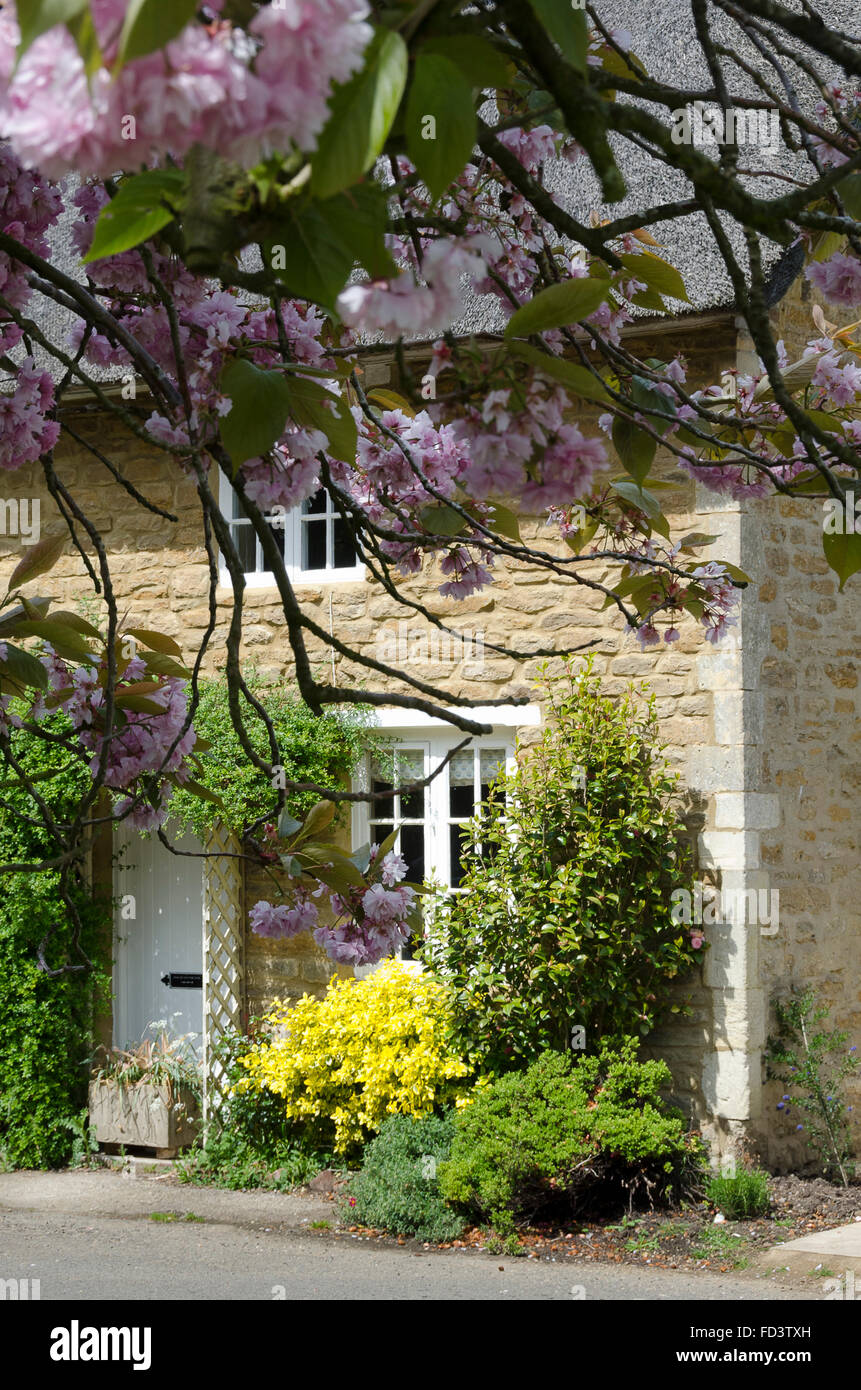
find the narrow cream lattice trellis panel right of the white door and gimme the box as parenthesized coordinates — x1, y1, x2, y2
(203, 826, 245, 1125)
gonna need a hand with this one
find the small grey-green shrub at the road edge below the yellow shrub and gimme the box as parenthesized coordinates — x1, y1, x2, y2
(342, 1115, 463, 1241)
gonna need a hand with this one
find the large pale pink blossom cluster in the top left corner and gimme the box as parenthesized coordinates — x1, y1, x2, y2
(0, 0, 373, 178)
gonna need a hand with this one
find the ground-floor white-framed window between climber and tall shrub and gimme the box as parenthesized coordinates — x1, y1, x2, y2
(352, 730, 513, 959)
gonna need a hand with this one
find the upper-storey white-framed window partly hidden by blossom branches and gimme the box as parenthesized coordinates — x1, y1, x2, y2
(221, 478, 364, 585)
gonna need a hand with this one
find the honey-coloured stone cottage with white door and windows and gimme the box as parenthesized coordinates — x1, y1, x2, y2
(0, 6, 861, 1166)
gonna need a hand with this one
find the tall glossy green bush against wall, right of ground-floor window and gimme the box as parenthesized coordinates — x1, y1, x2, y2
(419, 662, 700, 1072)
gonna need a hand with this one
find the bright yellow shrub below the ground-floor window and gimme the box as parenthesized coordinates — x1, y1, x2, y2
(236, 960, 476, 1154)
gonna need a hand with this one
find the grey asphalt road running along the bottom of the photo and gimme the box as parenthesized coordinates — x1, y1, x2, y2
(0, 1211, 810, 1311)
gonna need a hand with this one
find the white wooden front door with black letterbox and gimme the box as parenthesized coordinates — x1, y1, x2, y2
(114, 826, 203, 1051)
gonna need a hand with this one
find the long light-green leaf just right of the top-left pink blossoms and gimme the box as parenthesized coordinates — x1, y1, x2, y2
(312, 29, 408, 197)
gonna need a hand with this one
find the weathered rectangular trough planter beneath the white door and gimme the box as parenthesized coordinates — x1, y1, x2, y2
(89, 1081, 200, 1158)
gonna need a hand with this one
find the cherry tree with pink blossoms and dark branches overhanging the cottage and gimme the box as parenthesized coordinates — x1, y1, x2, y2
(0, 0, 861, 963)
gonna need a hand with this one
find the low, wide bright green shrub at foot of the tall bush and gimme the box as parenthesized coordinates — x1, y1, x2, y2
(440, 1038, 701, 1233)
